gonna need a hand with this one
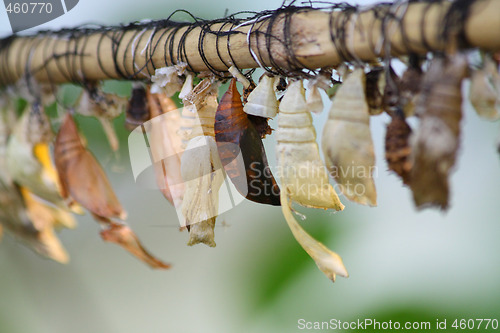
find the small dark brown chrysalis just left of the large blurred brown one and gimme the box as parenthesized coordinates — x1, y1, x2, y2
(385, 109, 411, 185)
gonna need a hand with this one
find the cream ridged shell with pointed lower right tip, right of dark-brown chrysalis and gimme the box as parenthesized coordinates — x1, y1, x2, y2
(277, 81, 344, 210)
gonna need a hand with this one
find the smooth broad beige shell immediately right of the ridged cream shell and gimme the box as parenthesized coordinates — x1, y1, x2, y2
(322, 68, 377, 206)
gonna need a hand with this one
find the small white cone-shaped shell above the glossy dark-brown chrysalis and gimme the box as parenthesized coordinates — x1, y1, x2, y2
(243, 74, 278, 118)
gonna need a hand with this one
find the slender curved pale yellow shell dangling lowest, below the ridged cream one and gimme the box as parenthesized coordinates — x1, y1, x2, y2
(280, 187, 349, 282)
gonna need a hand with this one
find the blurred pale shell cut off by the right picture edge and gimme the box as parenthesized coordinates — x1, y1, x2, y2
(469, 56, 500, 121)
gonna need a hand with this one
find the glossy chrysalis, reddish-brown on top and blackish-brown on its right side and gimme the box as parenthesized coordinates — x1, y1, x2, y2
(214, 79, 280, 206)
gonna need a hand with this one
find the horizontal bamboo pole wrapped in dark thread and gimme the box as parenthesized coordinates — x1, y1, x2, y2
(0, 0, 500, 86)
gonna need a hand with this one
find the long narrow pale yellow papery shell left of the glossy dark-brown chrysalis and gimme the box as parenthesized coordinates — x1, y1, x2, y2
(181, 79, 225, 247)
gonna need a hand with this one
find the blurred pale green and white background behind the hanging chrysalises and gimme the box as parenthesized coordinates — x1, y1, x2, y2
(0, 0, 500, 333)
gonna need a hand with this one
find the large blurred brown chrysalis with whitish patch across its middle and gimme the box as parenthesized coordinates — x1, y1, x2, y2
(410, 53, 468, 209)
